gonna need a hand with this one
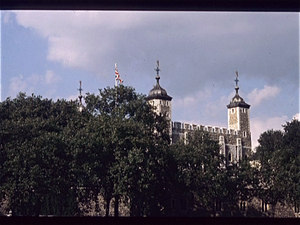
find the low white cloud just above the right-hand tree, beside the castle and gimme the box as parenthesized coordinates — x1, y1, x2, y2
(250, 116, 289, 148)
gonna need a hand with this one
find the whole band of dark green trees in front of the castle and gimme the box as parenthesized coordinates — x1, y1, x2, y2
(0, 86, 300, 216)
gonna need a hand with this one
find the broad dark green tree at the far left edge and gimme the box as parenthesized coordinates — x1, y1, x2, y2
(0, 93, 79, 216)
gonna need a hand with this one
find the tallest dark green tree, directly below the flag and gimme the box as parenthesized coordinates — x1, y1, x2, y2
(85, 85, 169, 216)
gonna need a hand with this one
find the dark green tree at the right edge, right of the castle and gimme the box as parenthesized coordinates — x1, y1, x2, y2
(254, 120, 300, 214)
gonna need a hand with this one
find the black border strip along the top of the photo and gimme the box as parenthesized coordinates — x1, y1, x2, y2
(0, 0, 300, 12)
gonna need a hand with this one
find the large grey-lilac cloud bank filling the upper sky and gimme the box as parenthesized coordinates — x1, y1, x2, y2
(10, 11, 298, 95)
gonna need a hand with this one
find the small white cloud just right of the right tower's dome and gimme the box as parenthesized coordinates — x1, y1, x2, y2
(247, 85, 280, 107)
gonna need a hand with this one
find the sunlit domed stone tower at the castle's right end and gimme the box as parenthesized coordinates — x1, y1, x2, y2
(227, 71, 251, 137)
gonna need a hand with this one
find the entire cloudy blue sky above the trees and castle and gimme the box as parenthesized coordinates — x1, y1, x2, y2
(0, 11, 299, 147)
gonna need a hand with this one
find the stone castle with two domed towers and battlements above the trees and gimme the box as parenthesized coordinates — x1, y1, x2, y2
(146, 61, 251, 163)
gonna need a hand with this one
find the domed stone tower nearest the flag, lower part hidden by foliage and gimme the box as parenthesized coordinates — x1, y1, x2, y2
(146, 60, 172, 132)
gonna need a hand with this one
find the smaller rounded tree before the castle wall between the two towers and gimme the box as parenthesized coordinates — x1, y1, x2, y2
(173, 131, 225, 214)
